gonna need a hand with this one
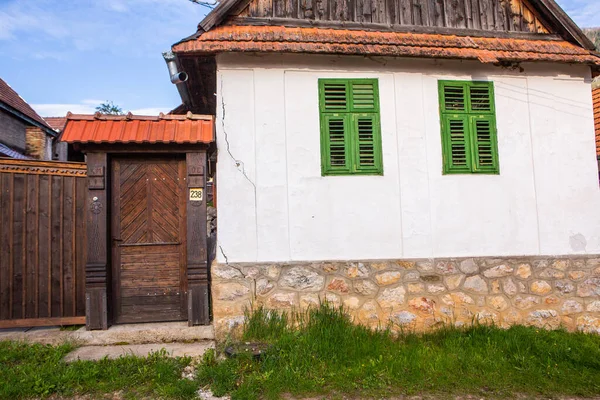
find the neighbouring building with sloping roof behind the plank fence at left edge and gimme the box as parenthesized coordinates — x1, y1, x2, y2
(0, 79, 57, 160)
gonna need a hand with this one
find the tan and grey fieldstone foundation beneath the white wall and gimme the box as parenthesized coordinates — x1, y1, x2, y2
(211, 256, 600, 338)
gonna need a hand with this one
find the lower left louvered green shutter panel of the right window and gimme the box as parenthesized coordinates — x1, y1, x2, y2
(442, 114, 471, 173)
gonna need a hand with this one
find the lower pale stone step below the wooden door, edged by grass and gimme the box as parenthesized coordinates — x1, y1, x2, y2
(64, 340, 215, 363)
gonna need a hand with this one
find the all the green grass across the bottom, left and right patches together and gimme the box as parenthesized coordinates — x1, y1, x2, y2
(0, 305, 600, 400)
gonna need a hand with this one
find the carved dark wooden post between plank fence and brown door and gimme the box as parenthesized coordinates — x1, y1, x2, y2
(85, 153, 109, 330)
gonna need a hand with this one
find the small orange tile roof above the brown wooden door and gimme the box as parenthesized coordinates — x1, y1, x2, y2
(61, 113, 214, 144)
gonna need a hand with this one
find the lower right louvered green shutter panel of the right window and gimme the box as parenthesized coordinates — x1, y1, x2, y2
(470, 116, 498, 172)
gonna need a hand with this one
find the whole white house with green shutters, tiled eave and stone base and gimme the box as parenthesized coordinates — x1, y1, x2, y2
(168, 0, 600, 334)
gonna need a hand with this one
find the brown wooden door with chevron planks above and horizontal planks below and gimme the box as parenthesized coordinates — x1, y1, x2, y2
(111, 156, 187, 323)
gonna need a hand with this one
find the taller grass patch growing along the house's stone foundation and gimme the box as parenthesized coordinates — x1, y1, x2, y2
(198, 305, 600, 399)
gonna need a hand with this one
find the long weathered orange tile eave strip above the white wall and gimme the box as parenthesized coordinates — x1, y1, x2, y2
(173, 25, 600, 65)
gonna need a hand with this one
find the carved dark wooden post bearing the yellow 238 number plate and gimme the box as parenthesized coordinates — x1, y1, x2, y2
(186, 150, 210, 326)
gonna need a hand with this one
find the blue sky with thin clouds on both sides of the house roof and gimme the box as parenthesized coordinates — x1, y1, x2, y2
(0, 0, 600, 116)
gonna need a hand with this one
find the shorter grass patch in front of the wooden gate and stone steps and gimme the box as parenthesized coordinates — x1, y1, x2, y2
(0, 342, 197, 399)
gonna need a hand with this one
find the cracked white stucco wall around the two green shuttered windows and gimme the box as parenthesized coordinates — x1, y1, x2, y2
(217, 54, 600, 262)
